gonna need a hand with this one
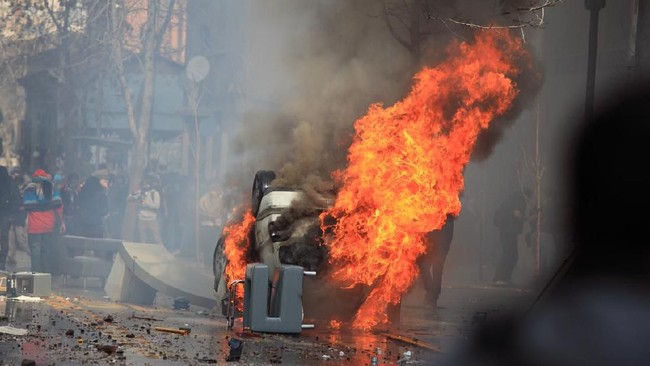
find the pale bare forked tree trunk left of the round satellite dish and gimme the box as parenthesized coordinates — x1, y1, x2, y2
(110, 0, 175, 239)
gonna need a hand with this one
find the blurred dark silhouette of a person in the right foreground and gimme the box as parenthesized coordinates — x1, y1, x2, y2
(453, 84, 650, 365)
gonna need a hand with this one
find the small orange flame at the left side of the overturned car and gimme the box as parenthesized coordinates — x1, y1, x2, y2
(223, 209, 255, 303)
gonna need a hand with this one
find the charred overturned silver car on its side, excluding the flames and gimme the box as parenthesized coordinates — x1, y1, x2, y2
(213, 171, 378, 320)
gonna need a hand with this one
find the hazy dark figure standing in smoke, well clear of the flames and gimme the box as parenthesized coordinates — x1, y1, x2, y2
(494, 191, 527, 285)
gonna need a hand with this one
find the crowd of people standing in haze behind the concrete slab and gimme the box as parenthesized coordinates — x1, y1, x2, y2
(0, 162, 231, 272)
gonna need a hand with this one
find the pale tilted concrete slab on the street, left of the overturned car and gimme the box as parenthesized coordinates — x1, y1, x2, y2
(104, 241, 217, 309)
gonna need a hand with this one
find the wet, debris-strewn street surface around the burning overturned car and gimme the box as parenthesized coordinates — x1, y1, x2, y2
(0, 249, 534, 365)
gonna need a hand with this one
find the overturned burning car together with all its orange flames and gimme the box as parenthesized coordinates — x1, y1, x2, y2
(215, 32, 539, 330)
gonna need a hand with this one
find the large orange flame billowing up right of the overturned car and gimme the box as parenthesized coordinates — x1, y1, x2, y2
(321, 31, 528, 329)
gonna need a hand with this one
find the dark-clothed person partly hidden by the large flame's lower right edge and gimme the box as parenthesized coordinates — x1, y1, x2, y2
(417, 215, 456, 307)
